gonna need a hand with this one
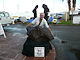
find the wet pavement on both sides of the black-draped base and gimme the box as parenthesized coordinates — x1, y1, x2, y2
(0, 24, 80, 60)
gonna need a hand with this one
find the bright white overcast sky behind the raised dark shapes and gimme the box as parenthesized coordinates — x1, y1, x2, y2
(0, 0, 80, 16)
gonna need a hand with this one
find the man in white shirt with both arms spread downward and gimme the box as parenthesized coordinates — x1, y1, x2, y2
(27, 13, 52, 33)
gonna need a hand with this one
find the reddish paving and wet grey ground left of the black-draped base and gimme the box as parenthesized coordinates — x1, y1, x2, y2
(0, 24, 27, 60)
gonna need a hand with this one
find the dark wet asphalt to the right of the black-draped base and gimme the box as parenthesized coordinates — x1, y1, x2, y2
(51, 25, 80, 60)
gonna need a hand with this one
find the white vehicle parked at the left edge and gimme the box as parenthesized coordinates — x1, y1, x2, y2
(0, 12, 12, 25)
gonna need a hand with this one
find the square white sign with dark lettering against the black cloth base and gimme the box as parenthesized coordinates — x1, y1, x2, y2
(34, 47, 45, 57)
